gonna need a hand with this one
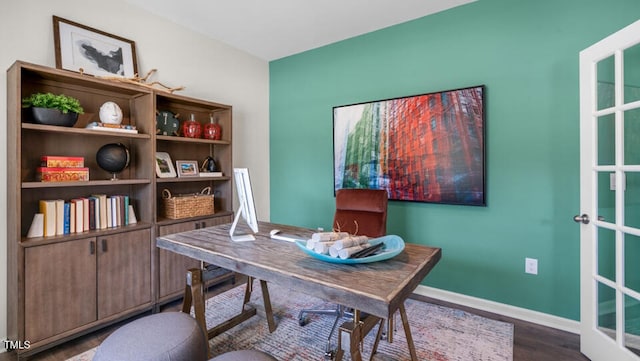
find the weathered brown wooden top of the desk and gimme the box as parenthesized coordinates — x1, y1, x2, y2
(157, 222, 441, 318)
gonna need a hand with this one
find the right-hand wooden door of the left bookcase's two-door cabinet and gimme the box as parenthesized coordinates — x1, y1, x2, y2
(96, 229, 151, 319)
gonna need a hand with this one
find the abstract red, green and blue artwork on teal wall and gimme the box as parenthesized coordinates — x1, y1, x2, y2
(333, 86, 486, 206)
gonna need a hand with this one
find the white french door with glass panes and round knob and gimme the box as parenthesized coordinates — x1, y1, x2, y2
(574, 21, 640, 361)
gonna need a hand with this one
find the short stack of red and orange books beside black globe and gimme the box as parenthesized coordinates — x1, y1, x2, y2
(37, 155, 89, 182)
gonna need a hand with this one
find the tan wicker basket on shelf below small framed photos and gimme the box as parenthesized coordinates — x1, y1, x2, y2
(162, 187, 214, 219)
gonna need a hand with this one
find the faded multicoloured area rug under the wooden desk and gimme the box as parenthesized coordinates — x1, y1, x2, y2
(68, 282, 513, 361)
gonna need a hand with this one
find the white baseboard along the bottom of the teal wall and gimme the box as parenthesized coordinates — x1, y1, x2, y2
(414, 285, 580, 334)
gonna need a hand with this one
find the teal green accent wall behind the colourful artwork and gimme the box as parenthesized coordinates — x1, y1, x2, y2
(270, 0, 640, 320)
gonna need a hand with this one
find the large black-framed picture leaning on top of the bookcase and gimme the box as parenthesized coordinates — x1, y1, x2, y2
(53, 15, 138, 78)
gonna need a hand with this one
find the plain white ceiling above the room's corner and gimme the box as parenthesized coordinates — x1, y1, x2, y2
(126, 0, 476, 60)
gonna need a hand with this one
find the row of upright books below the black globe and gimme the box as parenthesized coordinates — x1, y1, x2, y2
(27, 194, 137, 238)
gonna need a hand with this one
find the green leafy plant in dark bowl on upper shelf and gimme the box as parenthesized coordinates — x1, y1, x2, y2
(22, 93, 84, 127)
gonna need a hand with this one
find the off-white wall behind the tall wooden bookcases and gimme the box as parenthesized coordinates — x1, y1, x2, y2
(0, 0, 269, 350)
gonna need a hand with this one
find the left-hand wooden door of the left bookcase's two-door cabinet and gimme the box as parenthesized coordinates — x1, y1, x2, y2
(24, 238, 96, 342)
